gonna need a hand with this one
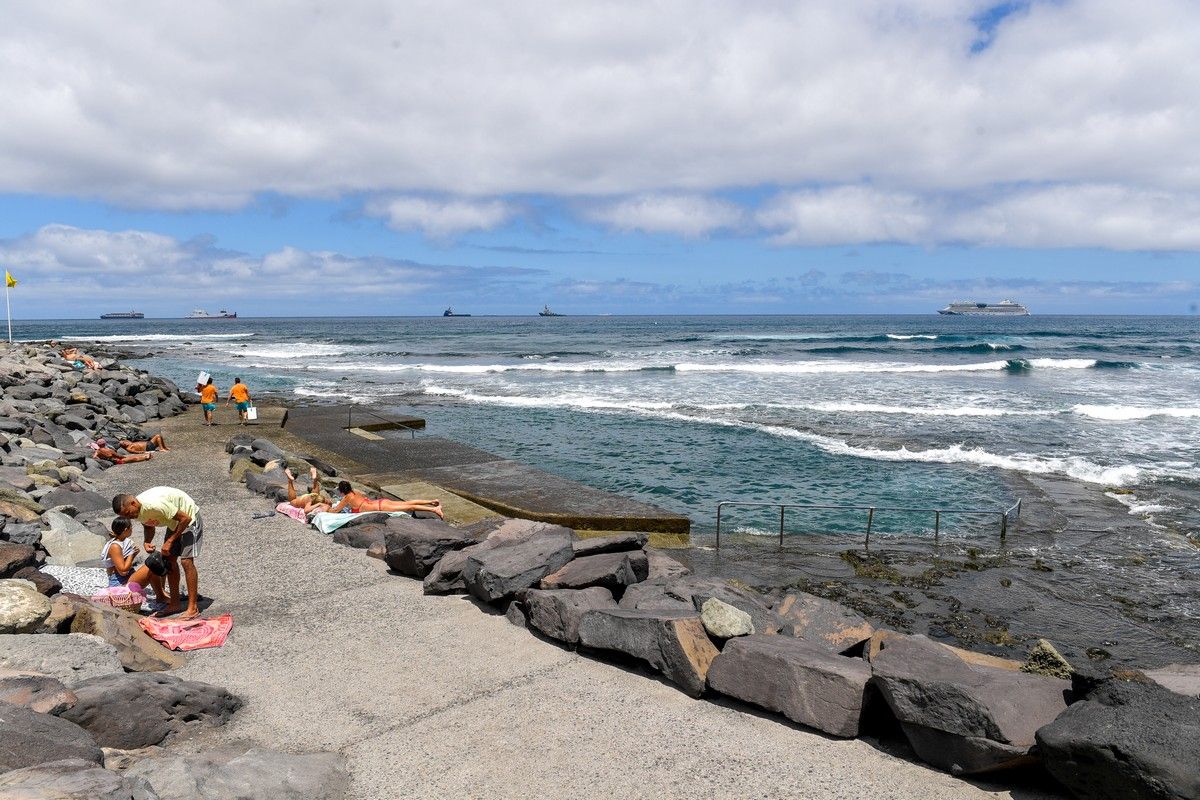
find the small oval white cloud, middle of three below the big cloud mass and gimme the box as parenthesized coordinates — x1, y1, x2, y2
(583, 194, 743, 236)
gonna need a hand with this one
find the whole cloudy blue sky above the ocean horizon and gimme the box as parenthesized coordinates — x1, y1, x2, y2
(0, 0, 1200, 319)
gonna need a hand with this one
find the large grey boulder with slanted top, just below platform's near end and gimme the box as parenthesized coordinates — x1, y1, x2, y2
(462, 529, 574, 603)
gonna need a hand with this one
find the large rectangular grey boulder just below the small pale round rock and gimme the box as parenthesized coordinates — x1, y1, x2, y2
(708, 633, 871, 738)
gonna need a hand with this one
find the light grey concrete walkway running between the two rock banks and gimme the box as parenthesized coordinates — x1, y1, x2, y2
(102, 407, 1048, 800)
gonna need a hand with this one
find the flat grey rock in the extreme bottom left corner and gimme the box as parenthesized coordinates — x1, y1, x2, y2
(0, 758, 160, 800)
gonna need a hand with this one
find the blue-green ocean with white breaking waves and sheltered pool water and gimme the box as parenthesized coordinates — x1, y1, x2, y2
(28, 314, 1200, 666)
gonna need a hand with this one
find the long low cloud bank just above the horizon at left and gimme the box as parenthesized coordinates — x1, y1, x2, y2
(0, 224, 542, 317)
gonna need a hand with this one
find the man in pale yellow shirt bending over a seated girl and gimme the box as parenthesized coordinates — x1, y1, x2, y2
(113, 486, 204, 619)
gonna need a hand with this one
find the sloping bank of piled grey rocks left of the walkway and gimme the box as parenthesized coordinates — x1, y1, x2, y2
(0, 345, 346, 800)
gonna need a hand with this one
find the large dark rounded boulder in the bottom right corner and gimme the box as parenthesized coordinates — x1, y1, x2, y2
(1037, 680, 1200, 800)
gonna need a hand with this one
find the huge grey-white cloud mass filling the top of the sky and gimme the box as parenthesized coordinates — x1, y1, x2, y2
(0, 0, 1200, 248)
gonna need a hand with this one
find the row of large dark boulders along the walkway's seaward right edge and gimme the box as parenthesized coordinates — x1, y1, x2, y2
(227, 437, 1200, 799)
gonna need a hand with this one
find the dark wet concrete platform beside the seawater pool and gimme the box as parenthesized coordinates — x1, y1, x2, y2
(283, 407, 691, 545)
